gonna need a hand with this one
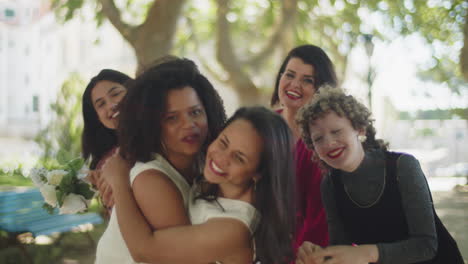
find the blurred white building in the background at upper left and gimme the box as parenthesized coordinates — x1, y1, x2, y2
(0, 0, 135, 138)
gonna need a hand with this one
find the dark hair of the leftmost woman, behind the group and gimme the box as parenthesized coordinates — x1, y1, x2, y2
(81, 69, 131, 169)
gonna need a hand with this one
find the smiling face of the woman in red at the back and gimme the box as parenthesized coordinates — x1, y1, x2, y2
(278, 57, 316, 110)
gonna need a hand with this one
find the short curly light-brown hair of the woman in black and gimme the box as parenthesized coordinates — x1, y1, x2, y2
(296, 87, 388, 170)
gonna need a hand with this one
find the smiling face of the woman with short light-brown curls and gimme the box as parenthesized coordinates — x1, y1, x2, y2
(309, 111, 365, 172)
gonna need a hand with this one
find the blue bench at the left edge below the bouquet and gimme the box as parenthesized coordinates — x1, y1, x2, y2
(0, 188, 103, 259)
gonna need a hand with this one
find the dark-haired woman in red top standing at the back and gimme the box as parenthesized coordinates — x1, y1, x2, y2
(271, 45, 337, 250)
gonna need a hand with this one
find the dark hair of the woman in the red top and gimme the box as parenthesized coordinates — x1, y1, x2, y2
(270, 45, 338, 106)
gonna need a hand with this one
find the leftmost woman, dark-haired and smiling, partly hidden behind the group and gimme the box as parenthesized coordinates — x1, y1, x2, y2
(81, 69, 131, 208)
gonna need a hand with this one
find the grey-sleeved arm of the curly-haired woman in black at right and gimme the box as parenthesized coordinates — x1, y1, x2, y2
(377, 155, 437, 264)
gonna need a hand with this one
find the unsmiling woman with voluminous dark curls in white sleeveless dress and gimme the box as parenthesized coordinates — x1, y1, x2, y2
(96, 59, 226, 264)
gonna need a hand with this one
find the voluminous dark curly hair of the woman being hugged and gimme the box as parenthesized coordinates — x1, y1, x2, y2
(118, 58, 226, 162)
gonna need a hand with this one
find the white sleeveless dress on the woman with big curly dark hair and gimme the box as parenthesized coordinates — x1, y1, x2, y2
(95, 154, 190, 264)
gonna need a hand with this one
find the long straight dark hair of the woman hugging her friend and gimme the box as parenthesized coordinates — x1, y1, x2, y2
(198, 106, 295, 263)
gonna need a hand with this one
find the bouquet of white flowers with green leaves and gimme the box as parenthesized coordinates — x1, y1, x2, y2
(29, 158, 95, 214)
